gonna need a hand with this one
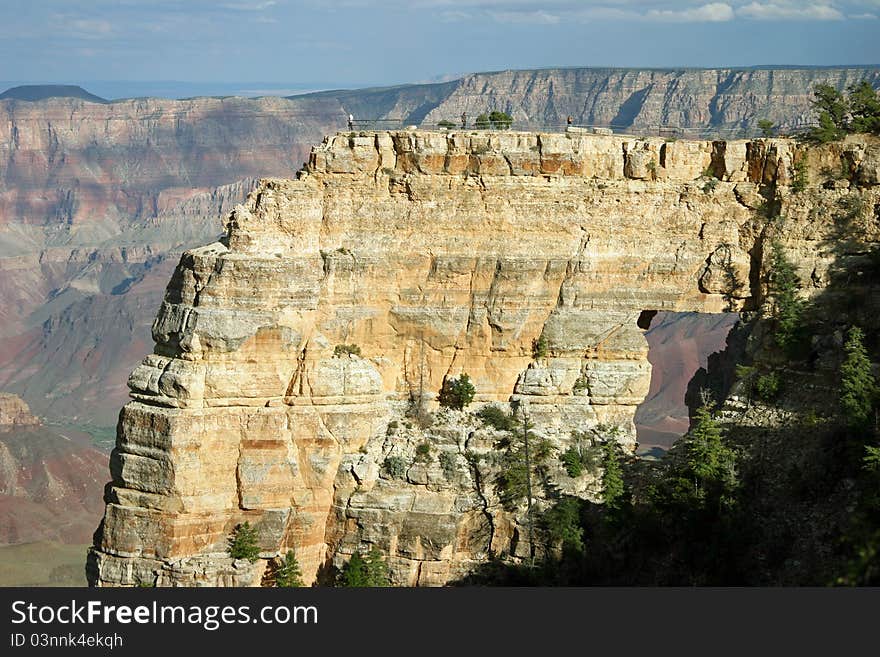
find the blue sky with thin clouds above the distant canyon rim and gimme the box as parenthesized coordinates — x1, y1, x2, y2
(0, 0, 880, 92)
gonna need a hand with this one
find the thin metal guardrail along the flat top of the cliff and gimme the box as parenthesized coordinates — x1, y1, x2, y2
(348, 119, 816, 141)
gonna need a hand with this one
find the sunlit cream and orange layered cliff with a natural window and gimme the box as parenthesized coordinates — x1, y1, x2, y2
(90, 131, 880, 585)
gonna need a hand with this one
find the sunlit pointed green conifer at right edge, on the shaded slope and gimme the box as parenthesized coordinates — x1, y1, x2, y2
(840, 326, 877, 432)
